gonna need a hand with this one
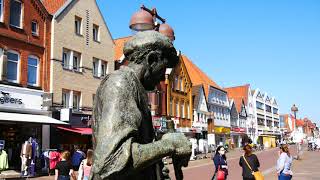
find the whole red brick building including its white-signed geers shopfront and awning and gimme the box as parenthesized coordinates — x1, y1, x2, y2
(0, 0, 65, 172)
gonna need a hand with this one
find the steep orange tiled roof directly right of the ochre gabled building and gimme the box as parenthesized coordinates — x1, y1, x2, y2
(182, 55, 224, 98)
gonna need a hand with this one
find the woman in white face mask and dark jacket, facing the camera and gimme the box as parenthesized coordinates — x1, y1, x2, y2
(212, 146, 228, 180)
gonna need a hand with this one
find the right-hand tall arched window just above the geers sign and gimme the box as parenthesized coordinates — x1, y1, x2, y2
(28, 56, 39, 86)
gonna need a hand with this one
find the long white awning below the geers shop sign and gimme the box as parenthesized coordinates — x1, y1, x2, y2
(0, 112, 68, 125)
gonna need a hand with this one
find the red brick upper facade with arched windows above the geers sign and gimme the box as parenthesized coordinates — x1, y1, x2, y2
(0, 0, 52, 92)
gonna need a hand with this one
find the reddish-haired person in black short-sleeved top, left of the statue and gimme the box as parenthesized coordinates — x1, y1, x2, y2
(55, 151, 74, 180)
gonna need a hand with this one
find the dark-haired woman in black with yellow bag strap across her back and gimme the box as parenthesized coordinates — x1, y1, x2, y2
(239, 144, 260, 180)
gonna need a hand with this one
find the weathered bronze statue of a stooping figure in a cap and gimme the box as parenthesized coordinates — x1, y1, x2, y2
(90, 31, 191, 180)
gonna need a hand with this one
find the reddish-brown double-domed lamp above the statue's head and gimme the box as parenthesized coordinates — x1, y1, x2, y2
(129, 5, 175, 41)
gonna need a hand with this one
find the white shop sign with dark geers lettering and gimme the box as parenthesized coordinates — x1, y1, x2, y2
(0, 85, 43, 110)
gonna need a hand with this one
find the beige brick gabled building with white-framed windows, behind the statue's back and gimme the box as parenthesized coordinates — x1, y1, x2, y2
(43, 0, 115, 143)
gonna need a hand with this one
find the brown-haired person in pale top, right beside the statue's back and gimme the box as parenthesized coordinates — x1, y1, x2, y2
(78, 149, 93, 180)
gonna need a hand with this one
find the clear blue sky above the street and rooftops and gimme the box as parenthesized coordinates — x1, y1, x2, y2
(97, 0, 320, 124)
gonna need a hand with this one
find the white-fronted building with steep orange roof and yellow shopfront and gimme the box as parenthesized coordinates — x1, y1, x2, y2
(183, 56, 230, 145)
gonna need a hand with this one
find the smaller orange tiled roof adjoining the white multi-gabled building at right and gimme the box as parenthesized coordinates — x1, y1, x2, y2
(224, 84, 250, 112)
